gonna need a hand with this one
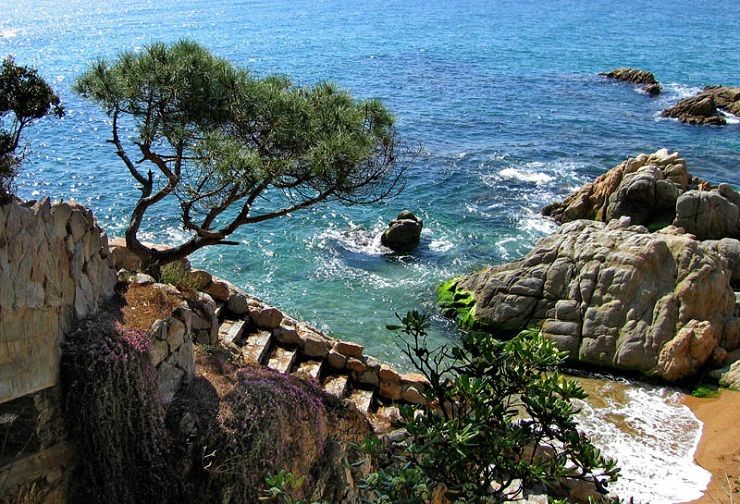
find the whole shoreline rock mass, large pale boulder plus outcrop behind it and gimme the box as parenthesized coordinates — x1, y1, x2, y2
(439, 149, 740, 387)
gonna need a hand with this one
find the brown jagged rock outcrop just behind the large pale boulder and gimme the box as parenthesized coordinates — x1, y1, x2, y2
(542, 149, 740, 240)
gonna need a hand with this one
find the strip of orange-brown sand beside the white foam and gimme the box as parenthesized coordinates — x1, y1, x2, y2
(684, 389, 740, 504)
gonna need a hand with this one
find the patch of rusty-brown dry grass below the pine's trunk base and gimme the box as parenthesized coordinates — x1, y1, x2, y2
(121, 285, 182, 331)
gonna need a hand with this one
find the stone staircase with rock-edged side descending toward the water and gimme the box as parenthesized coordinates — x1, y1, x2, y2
(217, 306, 427, 424)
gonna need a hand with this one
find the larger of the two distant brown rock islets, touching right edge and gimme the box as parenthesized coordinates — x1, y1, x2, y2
(662, 86, 740, 126)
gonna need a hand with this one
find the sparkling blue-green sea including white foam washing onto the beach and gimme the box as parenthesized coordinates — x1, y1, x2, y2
(0, 0, 740, 503)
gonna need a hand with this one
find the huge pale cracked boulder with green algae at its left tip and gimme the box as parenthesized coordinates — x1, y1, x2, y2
(442, 218, 737, 381)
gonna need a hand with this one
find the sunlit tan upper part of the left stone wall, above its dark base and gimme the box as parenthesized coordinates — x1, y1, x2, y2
(0, 198, 116, 403)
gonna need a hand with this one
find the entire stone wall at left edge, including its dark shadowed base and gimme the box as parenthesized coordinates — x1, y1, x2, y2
(0, 198, 116, 504)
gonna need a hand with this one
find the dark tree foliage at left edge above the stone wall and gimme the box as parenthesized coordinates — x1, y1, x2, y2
(0, 56, 64, 203)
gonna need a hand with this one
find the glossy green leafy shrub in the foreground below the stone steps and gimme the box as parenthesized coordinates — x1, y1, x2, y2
(366, 312, 619, 503)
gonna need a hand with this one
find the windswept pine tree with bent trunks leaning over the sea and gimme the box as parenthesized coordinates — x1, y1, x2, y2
(76, 41, 403, 269)
